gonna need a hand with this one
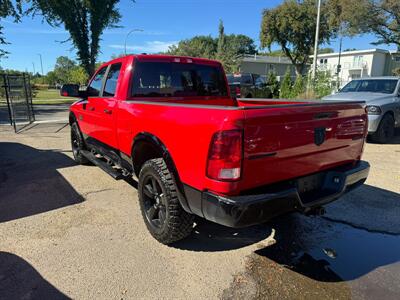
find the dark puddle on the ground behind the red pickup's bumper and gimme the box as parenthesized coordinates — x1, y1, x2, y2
(256, 216, 400, 282)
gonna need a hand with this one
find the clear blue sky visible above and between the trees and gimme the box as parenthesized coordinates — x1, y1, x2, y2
(0, 0, 395, 73)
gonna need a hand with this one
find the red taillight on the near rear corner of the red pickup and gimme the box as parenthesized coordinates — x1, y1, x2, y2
(207, 130, 243, 181)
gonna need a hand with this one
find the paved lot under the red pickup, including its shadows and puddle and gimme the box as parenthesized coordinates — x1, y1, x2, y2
(0, 124, 400, 299)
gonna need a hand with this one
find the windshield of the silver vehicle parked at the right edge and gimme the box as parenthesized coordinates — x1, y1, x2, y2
(340, 79, 398, 94)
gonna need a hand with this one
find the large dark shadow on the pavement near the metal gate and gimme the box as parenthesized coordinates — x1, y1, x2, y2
(0, 142, 84, 222)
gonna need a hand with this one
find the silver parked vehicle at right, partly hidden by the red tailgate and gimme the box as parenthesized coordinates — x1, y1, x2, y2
(323, 77, 400, 143)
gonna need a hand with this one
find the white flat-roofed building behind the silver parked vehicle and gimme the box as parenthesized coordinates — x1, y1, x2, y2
(317, 49, 400, 86)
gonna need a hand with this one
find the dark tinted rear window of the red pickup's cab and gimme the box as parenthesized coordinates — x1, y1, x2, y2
(131, 62, 228, 97)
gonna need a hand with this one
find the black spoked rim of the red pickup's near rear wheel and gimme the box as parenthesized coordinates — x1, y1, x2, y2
(142, 175, 167, 229)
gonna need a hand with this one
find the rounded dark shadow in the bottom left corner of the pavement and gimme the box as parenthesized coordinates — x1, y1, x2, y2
(0, 251, 71, 299)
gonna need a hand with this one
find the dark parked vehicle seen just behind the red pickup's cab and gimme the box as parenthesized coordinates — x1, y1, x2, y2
(226, 73, 271, 98)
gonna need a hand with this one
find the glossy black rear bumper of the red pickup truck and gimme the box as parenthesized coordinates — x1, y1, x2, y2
(185, 161, 370, 227)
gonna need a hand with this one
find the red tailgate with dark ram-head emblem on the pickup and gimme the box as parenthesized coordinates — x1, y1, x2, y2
(239, 101, 367, 189)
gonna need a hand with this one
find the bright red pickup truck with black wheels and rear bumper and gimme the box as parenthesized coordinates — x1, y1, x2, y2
(61, 54, 369, 244)
